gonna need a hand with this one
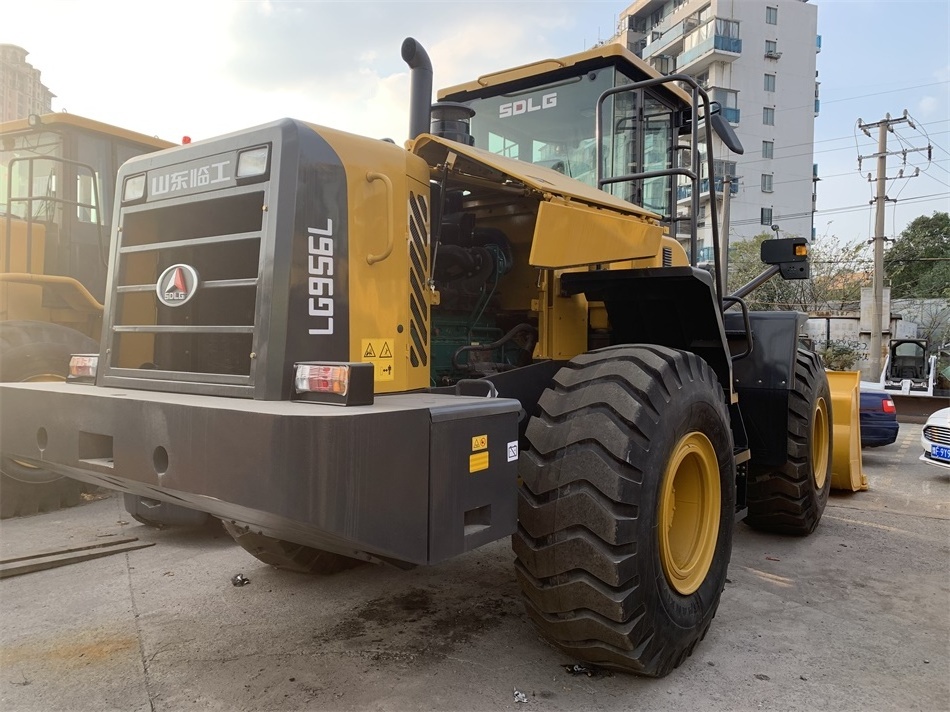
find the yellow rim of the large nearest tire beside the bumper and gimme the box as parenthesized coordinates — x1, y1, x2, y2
(659, 432, 721, 596)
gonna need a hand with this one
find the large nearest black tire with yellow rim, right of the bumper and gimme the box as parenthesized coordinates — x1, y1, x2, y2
(512, 346, 735, 677)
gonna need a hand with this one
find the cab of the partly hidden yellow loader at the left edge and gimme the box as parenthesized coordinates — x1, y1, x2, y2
(0, 113, 173, 304)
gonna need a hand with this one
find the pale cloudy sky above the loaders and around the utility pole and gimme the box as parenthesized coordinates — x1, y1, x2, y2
(0, 0, 950, 242)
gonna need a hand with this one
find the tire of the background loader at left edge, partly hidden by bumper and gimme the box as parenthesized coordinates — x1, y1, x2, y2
(0, 321, 99, 519)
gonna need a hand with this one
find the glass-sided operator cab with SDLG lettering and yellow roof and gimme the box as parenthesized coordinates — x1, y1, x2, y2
(439, 45, 695, 249)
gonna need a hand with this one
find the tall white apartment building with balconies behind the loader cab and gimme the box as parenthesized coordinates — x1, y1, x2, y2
(612, 0, 821, 256)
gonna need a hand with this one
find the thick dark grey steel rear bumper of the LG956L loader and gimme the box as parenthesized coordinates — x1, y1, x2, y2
(0, 383, 520, 564)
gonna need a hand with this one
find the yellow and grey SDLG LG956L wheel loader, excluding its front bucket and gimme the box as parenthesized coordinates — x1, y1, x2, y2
(0, 39, 856, 676)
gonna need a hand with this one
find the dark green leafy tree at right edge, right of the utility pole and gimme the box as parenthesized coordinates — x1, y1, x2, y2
(884, 212, 950, 299)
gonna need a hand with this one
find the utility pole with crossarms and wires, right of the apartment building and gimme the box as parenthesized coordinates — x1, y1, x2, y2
(858, 109, 925, 381)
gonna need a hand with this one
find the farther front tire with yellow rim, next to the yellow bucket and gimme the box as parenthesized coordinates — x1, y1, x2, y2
(745, 349, 832, 536)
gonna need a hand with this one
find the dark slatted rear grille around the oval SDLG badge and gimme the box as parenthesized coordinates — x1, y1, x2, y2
(108, 185, 264, 386)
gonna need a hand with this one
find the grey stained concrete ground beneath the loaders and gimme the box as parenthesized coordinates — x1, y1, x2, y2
(0, 424, 950, 712)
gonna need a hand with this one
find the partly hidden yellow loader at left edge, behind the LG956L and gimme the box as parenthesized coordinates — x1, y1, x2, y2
(0, 113, 172, 518)
